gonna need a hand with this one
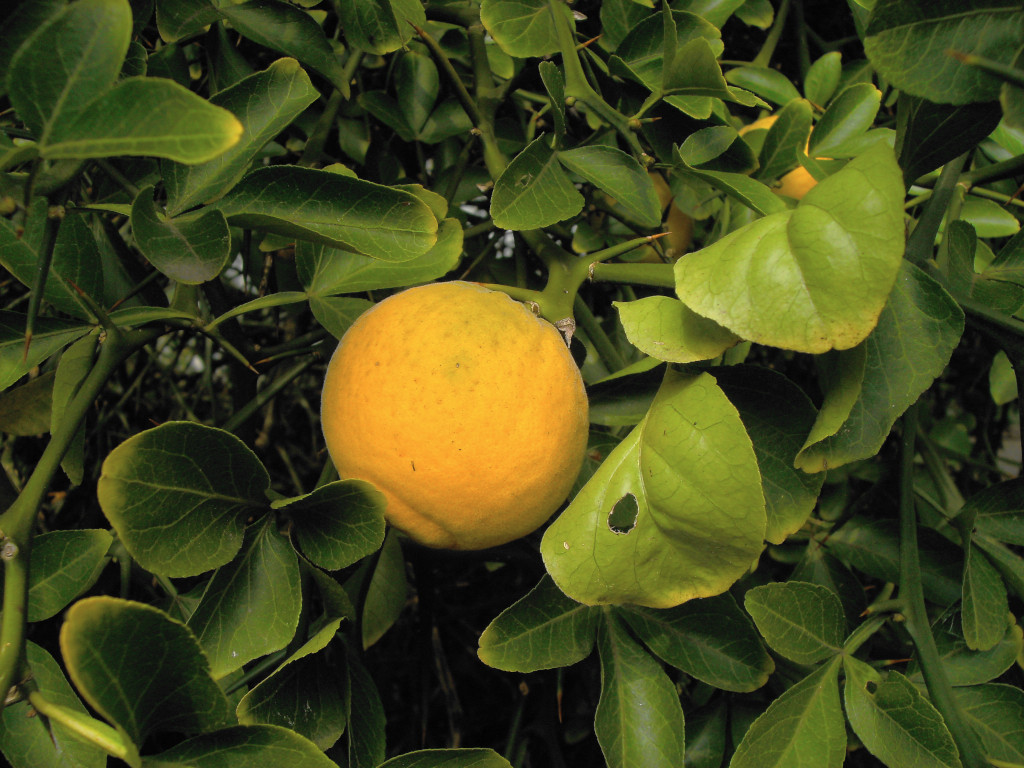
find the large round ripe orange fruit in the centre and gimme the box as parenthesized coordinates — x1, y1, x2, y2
(321, 282, 589, 550)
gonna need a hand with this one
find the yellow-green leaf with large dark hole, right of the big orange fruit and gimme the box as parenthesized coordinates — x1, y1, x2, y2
(541, 373, 765, 607)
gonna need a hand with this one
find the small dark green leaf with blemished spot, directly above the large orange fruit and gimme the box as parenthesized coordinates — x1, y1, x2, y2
(490, 136, 589, 229)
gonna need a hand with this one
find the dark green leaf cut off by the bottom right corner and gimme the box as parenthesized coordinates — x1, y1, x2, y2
(953, 683, 1024, 765)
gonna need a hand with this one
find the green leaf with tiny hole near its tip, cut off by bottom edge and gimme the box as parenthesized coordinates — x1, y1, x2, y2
(843, 656, 961, 768)
